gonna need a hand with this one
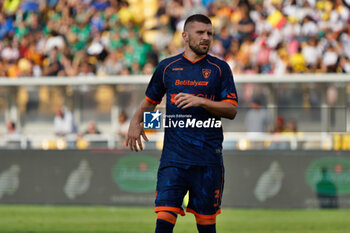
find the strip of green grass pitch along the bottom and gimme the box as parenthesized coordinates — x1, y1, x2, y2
(0, 205, 350, 233)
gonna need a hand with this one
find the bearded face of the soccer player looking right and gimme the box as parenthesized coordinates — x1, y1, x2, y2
(185, 22, 213, 56)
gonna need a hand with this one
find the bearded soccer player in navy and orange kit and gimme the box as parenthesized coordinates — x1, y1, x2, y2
(127, 14, 237, 233)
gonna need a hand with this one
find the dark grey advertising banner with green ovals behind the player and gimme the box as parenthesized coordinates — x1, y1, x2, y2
(0, 150, 350, 208)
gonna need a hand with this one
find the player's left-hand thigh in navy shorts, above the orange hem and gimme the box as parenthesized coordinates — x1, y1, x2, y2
(155, 166, 187, 209)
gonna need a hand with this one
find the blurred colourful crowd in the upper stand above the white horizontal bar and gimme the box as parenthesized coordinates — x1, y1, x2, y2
(0, 0, 350, 78)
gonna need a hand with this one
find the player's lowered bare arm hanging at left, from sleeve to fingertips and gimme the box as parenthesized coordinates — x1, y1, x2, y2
(126, 99, 156, 152)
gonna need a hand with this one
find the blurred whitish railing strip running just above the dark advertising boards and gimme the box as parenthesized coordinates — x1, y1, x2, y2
(0, 132, 336, 150)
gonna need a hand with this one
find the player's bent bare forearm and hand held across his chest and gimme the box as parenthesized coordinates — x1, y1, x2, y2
(175, 93, 237, 120)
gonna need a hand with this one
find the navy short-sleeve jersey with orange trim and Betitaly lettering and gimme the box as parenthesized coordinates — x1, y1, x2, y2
(146, 54, 238, 166)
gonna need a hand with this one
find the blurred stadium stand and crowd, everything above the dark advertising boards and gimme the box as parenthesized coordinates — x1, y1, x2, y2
(0, 0, 350, 150)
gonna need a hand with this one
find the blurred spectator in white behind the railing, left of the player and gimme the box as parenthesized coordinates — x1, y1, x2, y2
(54, 109, 77, 136)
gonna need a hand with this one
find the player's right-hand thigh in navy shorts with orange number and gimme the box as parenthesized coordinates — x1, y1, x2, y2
(187, 166, 225, 215)
